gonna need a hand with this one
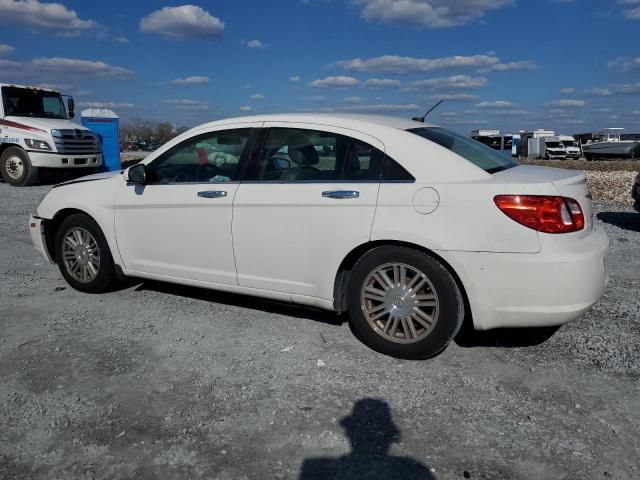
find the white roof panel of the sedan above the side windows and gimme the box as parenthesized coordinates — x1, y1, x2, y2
(200, 113, 435, 130)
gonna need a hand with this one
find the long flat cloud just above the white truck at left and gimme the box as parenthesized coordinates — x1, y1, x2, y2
(32, 57, 133, 80)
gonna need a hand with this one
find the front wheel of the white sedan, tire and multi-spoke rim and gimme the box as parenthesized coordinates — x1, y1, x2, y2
(55, 214, 117, 293)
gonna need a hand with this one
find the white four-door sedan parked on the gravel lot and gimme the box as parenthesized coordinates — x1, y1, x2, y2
(30, 115, 609, 358)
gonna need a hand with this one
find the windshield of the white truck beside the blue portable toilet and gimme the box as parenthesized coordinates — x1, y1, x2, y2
(2, 87, 67, 120)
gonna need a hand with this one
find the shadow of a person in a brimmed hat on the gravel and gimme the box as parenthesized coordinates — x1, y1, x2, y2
(299, 398, 435, 480)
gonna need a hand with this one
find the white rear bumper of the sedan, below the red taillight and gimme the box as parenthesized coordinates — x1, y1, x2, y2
(439, 226, 609, 330)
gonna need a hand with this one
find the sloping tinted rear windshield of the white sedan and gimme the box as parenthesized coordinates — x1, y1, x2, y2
(409, 127, 518, 173)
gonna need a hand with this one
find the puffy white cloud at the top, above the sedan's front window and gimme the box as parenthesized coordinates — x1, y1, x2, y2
(140, 5, 224, 40)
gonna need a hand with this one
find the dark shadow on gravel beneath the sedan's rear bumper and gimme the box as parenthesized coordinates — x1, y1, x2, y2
(454, 324, 560, 348)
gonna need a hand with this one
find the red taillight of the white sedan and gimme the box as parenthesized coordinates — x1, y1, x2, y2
(493, 195, 584, 233)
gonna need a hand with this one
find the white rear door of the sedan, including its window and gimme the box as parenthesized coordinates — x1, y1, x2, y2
(233, 122, 384, 300)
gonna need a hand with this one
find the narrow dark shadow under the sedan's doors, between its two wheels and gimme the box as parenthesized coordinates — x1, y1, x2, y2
(134, 280, 348, 325)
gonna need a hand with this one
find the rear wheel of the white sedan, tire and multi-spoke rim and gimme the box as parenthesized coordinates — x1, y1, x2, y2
(347, 246, 464, 360)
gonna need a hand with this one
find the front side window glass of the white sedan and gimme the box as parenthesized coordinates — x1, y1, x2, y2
(147, 128, 251, 184)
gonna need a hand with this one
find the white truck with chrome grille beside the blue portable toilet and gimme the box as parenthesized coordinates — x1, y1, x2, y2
(0, 83, 102, 186)
